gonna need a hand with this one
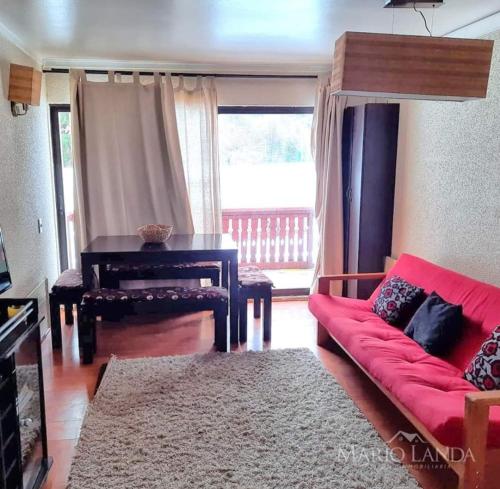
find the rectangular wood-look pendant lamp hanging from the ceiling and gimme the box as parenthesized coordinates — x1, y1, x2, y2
(332, 0, 493, 101)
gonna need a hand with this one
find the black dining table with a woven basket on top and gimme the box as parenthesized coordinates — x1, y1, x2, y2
(81, 234, 239, 343)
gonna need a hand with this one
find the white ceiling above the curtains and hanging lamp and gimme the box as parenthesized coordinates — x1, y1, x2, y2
(0, 0, 500, 72)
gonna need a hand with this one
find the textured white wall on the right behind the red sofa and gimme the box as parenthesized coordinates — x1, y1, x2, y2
(393, 32, 500, 285)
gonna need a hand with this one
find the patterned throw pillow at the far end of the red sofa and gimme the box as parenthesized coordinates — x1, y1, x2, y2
(373, 275, 425, 325)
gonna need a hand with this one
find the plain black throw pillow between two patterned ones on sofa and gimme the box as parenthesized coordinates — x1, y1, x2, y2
(405, 292, 463, 356)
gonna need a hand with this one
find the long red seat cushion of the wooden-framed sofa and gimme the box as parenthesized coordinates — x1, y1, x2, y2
(309, 288, 500, 448)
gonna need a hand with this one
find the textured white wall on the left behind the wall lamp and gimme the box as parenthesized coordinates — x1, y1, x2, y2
(0, 37, 57, 297)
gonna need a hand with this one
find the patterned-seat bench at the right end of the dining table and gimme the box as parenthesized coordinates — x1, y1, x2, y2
(238, 266, 273, 343)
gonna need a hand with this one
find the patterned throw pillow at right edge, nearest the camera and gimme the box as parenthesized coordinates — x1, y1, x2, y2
(464, 326, 500, 391)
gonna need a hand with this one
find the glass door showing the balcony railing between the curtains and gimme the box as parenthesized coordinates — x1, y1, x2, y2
(218, 106, 317, 295)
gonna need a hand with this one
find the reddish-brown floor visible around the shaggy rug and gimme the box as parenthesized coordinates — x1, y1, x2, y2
(43, 301, 457, 489)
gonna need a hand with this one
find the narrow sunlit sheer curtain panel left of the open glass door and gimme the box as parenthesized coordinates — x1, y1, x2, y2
(174, 76, 222, 233)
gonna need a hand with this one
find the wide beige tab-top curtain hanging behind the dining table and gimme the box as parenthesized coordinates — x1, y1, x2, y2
(70, 70, 194, 256)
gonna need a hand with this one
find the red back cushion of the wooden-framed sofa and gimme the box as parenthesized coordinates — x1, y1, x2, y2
(370, 254, 500, 370)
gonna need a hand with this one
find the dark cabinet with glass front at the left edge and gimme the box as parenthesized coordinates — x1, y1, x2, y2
(0, 299, 51, 489)
